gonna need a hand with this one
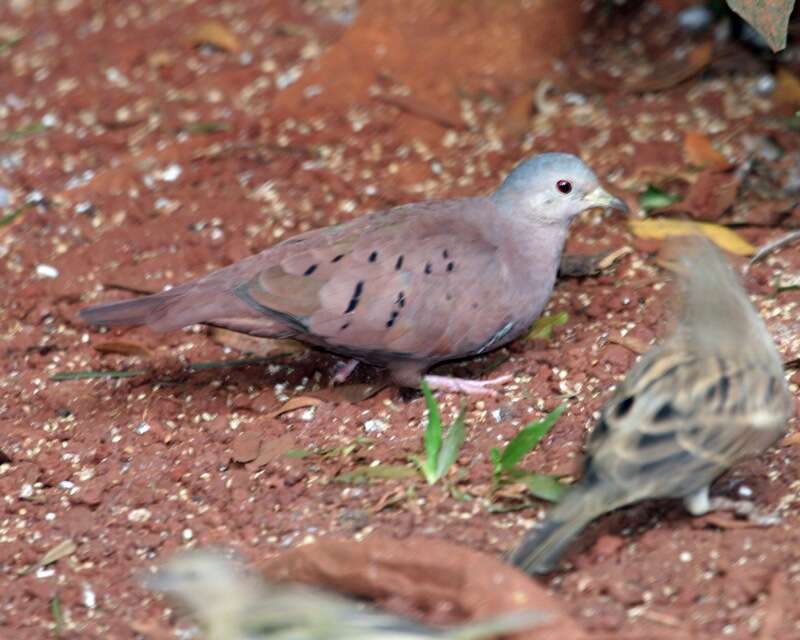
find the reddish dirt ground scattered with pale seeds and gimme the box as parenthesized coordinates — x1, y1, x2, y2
(0, 0, 800, 640)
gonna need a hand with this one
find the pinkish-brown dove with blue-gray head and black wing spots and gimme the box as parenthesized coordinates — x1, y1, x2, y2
(81, 153, 626, 393)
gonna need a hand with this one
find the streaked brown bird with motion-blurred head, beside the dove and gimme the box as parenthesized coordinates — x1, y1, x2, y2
(511, 237, 793, 573)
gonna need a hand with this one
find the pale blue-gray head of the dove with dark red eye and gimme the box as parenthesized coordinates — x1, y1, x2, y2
(492, 153, 628, 225)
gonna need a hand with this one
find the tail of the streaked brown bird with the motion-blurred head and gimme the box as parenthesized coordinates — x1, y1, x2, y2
(509, 486, 619, 574)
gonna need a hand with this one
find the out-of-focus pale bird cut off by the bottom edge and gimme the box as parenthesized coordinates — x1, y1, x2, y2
(144, 550, 549, 640)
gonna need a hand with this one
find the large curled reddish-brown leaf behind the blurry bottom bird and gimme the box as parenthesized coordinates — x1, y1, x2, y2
(260, 535, 587, 640)
